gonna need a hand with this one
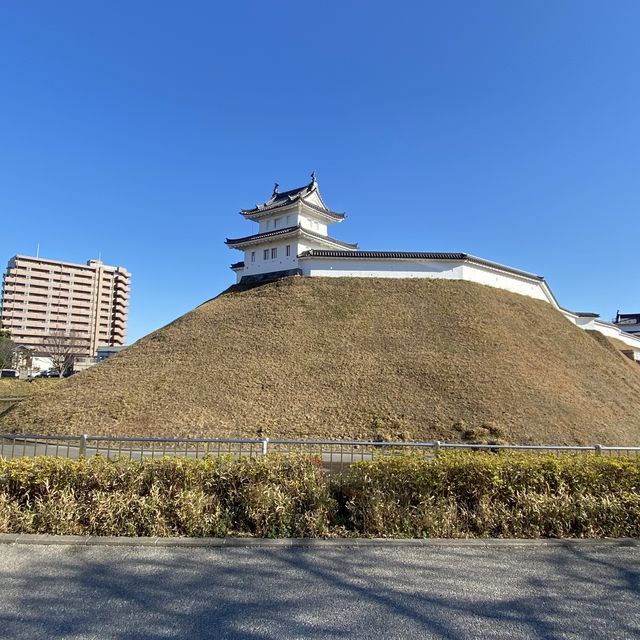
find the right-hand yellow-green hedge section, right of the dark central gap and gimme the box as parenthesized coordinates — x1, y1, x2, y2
(344, 453, 640, 538)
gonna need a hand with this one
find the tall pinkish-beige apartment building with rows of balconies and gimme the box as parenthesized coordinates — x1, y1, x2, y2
(0, 256, 131, 357)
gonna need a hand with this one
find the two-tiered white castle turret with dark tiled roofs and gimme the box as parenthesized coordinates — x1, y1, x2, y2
(226, 171, 358, 282)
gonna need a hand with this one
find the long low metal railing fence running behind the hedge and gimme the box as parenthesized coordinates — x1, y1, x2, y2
(0, 434, 640, 473)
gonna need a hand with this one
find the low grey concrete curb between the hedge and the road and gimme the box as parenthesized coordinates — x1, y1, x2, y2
(0, 533, 640, 549)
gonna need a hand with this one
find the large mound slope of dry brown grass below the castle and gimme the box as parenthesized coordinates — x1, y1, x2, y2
(0, 278, 640, 444)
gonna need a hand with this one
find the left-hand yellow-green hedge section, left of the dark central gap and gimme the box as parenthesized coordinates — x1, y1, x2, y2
(0, 454, 335, 537)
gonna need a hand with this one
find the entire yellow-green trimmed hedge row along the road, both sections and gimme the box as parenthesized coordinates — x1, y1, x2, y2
(0, 453, 640, 538)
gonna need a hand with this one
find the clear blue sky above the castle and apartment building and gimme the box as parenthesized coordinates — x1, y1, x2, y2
(0, 0, 640, 341)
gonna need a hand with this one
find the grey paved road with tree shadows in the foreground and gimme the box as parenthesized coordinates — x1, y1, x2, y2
(0, 543, 640, 640)
